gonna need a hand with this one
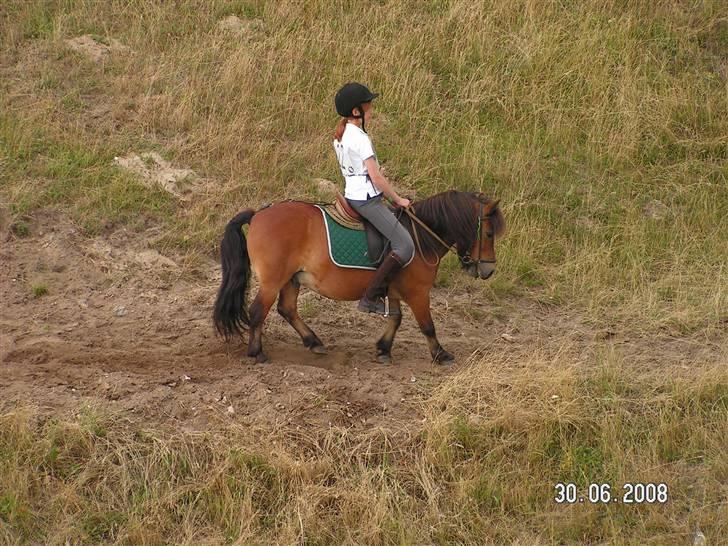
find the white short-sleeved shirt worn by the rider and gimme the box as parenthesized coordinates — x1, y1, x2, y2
(334, 123, 382, 201)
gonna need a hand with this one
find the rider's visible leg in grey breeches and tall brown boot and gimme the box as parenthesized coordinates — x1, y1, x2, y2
(349, 196, 415, 315)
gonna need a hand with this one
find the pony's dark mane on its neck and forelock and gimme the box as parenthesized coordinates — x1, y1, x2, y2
(405, 190, 505, 257)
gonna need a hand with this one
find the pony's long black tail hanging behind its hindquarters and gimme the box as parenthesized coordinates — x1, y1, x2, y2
(212, 209, 255, 341)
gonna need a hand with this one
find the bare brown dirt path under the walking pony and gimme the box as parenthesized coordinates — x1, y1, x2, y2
(0, 210, 725, 430)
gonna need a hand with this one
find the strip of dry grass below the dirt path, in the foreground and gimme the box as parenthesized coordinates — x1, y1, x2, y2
(0, 346, 728, 545)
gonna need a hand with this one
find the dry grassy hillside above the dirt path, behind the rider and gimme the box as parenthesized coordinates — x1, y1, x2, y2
(0, 0, 728, 332)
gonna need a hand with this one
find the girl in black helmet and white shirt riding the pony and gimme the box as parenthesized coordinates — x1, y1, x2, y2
(333, 82, 415, 315)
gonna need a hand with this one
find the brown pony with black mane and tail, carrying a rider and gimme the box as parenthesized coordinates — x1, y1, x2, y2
(213, 190, 505, 364)
